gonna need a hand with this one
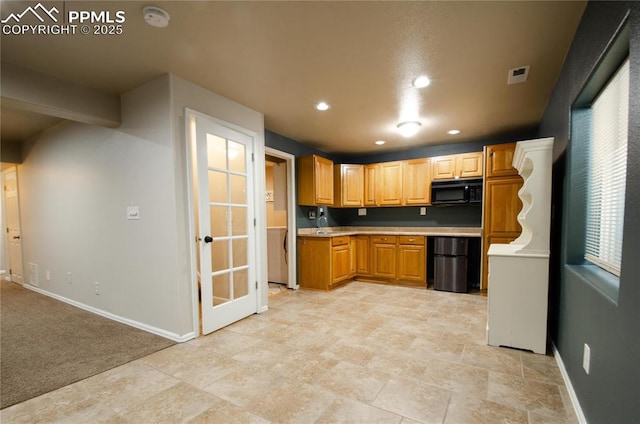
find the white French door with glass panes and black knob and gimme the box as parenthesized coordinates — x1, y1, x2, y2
(195, 117, 257, 334)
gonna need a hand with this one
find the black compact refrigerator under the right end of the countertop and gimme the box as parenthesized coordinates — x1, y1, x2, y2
(433, 237, 469, 293)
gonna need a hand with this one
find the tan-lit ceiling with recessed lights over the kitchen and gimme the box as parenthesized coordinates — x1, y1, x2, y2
(0, 1, 586, 153)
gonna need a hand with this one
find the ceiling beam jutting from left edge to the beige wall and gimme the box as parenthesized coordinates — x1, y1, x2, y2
(1, 62, 120, 127)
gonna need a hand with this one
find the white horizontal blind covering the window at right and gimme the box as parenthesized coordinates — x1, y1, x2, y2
(584, 59, 629, 276)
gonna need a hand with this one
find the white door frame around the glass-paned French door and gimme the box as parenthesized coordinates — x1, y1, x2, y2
(183, 107, 269, 338)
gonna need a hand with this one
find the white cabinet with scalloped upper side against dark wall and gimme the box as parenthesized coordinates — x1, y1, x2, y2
(487, 138, 553, 354)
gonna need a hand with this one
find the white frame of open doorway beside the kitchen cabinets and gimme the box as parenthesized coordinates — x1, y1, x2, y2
(264, 147, 300, 290)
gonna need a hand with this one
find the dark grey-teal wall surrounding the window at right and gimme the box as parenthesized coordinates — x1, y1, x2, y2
(539, 1, 640, 424)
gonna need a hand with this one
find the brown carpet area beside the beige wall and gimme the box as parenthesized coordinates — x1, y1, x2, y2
(0, 281, 175, 409)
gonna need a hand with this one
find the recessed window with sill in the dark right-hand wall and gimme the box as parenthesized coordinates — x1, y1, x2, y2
(561, 21, 630, 305)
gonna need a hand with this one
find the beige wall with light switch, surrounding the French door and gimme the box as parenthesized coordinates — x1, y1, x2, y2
(18, 75, 268, 341)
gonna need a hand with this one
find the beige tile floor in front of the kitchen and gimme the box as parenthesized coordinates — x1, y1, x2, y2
(0, 282, 577, 424)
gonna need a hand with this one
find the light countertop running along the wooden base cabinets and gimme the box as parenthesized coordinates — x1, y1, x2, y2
(298, 227, 482, 237)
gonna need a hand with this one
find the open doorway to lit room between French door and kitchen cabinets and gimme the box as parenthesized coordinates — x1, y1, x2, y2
(265, 147, 300, 295)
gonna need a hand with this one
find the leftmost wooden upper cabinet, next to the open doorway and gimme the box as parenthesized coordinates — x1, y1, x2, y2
(297, 155, 333, 206)
